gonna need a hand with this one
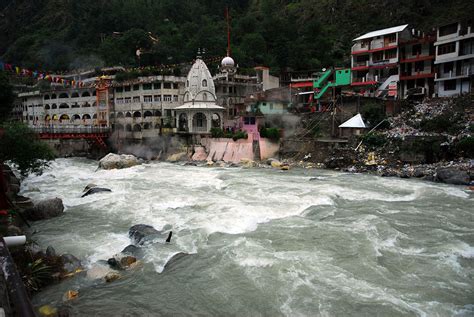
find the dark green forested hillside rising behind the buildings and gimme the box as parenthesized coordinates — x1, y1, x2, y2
(0, 0, 474, 71)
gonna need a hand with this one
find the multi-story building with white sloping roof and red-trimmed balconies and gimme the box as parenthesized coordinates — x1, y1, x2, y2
(351, 24, 410, 99)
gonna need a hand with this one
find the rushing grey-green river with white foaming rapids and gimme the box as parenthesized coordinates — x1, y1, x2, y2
(22, 158, 474, 316)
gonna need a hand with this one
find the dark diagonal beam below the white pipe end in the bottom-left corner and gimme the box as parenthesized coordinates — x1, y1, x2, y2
(0, 237, 36, 317)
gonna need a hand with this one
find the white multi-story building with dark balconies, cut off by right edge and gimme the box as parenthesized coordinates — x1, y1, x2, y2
(434, 23, 474, 97)
